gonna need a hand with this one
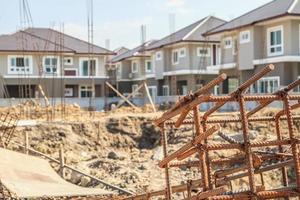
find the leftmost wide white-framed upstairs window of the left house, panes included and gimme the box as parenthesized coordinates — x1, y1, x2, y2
(7, 55, 33, 74)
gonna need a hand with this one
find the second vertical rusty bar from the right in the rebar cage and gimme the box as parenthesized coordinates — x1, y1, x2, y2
(238, 94, 256, 199)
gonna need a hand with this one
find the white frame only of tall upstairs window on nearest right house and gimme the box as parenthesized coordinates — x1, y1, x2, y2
(267, 25, 284, 56)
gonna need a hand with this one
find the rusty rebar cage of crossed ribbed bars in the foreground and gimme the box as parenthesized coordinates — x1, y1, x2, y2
(123, 65, 300, 200)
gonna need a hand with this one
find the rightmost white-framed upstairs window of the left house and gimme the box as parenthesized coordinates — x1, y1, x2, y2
(79, 58, 98, 76)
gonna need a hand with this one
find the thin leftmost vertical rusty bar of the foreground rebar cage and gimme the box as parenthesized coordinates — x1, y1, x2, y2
(160, 124, 172, 200)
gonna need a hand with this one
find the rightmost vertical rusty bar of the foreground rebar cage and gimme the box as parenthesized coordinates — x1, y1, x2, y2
(283, 94, 300, 192)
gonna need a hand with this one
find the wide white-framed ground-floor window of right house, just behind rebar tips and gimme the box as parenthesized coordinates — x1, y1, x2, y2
(257, 76, 280, 93)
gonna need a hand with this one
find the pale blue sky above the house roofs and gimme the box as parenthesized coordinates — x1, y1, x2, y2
(0, 0, 270, 49)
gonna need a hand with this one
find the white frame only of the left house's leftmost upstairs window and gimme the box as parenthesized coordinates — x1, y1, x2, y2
(7, 55, 33, 74)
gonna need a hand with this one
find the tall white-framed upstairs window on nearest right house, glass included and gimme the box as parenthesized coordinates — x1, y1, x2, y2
(267, 26, 284, 56)
